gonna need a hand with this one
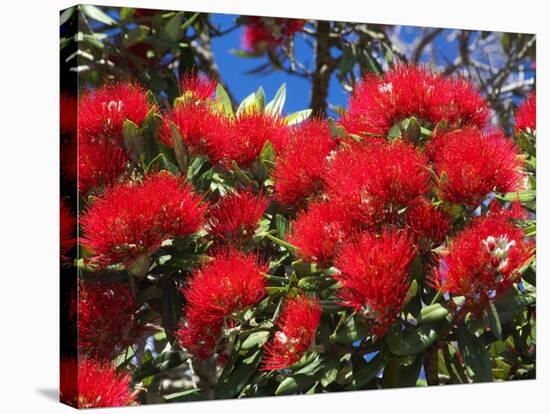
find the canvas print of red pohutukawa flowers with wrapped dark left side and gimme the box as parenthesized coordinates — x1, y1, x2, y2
(60, 5, 536, 408)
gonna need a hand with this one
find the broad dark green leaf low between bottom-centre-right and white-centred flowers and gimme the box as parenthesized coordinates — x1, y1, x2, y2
(387, 324, 437, 356)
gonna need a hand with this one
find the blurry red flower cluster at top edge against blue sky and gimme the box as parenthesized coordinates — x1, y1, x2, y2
(241, 17, 305, 54)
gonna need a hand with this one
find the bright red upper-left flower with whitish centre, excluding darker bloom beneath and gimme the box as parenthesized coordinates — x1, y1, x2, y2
(78, 82, 151, 141)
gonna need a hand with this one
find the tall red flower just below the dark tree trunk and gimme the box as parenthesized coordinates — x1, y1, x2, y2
(272, 120, 336, 204)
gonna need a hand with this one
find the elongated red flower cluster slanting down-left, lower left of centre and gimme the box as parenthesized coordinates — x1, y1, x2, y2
(177, 249, 267, 358)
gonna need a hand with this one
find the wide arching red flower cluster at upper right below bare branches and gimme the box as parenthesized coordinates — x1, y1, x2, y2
(341, 65, 488, 137)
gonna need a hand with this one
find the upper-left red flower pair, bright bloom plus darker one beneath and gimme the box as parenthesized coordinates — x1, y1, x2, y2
(78, 82, 151, 193)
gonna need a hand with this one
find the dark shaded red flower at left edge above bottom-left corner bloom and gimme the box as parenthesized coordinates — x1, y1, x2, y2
(77, 283, 149, 360)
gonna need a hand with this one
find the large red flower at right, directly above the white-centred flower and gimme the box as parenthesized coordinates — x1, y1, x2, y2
(427, 128, 524, 206)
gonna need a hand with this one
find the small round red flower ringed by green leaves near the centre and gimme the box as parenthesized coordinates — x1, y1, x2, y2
(208, 191, 269, 243)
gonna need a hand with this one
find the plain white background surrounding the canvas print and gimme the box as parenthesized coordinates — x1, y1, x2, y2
(0, 0, 550, 414)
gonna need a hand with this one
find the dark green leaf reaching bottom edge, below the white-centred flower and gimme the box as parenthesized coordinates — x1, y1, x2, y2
(458, 326, 493, 382)
